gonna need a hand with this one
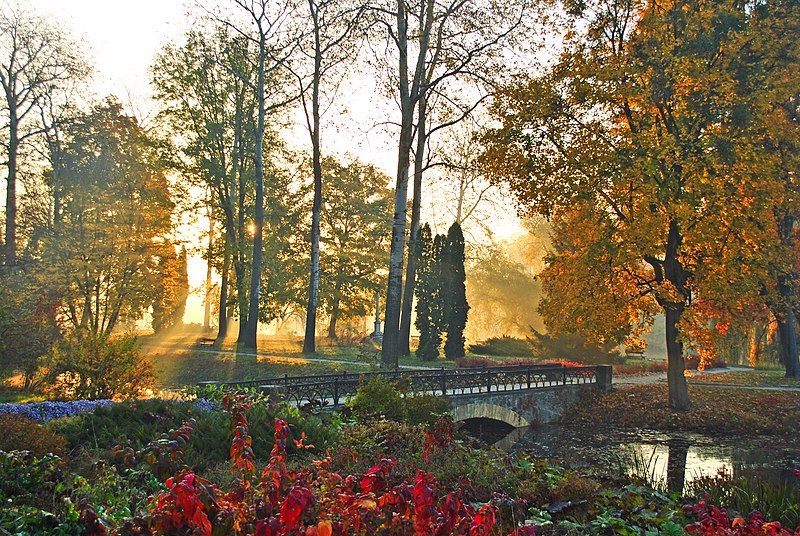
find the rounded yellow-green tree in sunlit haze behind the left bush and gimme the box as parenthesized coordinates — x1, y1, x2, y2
(46, 99, 174, 334)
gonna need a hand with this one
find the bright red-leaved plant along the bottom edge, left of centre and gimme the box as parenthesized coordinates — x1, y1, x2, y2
(126, 395, 520, 536)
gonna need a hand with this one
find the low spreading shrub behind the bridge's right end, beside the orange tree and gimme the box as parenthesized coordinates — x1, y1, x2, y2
(528, 329, 625, 365)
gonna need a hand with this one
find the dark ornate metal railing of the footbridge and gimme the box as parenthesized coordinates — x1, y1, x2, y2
(200, 364, 611, 408)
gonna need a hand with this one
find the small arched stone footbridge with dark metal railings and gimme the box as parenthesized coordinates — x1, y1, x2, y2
(199, 364, 611, 428)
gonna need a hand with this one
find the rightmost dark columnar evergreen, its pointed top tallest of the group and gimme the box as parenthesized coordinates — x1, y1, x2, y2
(439, 222, 469, 359)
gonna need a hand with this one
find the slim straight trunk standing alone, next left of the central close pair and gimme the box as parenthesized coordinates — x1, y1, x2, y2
(303, 19, 322, 353)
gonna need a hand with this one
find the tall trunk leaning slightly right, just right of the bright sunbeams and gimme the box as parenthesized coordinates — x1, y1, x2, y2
(243, 32, 266, 351)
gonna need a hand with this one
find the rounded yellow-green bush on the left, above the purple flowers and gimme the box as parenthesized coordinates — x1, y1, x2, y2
(49, 330, 155, 400)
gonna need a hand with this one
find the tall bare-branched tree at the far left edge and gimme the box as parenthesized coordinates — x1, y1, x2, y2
(0, 4, 88, 266)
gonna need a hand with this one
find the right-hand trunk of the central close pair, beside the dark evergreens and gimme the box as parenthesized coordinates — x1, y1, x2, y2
(399, 90, 427, 355)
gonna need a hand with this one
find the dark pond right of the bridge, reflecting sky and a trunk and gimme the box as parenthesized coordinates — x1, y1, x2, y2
(510, 425, 800, 491)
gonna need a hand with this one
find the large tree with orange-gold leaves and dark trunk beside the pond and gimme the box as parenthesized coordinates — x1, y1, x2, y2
(485, 0, 792, 410)
